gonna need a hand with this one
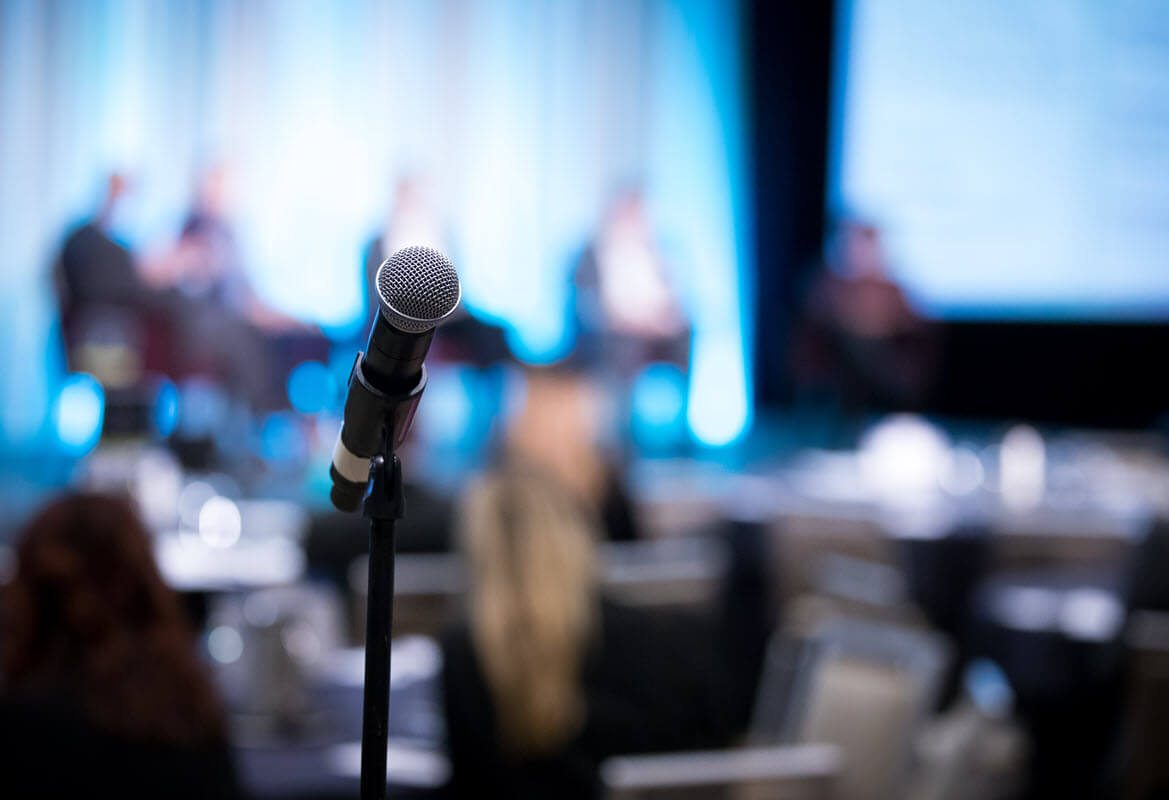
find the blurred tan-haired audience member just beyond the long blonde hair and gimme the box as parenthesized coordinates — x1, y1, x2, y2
(503, 357, 639, 542)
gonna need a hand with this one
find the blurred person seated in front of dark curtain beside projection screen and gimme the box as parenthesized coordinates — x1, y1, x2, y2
(793, 219, 936, 413)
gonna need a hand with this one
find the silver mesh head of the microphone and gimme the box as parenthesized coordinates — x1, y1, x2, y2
(374, 247, 462, 333)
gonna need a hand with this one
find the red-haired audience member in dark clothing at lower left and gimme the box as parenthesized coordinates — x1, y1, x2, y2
(0, 495, 238, 798)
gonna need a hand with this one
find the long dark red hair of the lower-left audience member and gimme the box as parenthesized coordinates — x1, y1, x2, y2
(0, 495, 223, 742)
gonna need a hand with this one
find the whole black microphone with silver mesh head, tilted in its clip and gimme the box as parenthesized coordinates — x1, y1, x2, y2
(328, 247, 462, 511)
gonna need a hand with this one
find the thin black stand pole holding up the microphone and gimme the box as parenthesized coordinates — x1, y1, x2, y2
(361, 446, 406, 800)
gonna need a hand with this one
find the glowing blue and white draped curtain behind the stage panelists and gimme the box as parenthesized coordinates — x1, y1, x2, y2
(0, 0, 750, 451)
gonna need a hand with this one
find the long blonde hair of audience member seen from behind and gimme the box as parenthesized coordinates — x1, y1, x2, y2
(462, 469, 597, 756)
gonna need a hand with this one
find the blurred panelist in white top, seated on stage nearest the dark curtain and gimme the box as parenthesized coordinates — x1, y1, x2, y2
(572, 188, 691, 379)
